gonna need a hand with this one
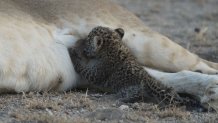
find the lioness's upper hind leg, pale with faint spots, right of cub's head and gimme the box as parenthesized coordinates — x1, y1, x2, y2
(124, 30, 218, 74)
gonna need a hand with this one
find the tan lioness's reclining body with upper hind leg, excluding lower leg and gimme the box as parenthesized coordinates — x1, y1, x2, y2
(0, 0, 218, 92)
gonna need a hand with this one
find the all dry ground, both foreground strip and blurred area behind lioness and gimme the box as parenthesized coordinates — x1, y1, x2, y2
(0, 0, 218, 123)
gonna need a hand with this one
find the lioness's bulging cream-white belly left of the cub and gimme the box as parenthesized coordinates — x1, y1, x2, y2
(0, 13, 77, 92)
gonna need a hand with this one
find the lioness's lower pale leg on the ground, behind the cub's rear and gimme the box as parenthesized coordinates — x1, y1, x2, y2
(144, 67, 218, 110)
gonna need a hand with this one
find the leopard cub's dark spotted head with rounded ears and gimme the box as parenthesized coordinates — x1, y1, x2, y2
(83, 26, 124, 57)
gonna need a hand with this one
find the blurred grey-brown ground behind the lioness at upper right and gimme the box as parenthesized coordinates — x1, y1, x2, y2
(112, 0, 218, 62)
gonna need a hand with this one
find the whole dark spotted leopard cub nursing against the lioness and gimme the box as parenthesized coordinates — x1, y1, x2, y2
(70, 26, 196, 104)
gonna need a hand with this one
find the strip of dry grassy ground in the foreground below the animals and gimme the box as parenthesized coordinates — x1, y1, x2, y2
(0, 92, 218, 123)
